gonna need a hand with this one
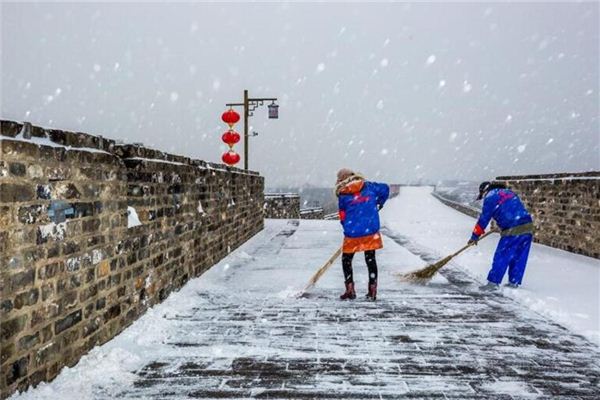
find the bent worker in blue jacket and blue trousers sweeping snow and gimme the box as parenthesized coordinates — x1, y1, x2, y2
(469, 182, 534, 290)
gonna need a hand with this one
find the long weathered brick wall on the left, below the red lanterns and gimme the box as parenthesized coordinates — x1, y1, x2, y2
(0, 121, 264, 397)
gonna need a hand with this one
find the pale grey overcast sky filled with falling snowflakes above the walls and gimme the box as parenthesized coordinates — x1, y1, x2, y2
(1, 2, 600, 187)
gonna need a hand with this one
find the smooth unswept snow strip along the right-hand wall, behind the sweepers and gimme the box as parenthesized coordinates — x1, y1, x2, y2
(382, 187, 600, 345)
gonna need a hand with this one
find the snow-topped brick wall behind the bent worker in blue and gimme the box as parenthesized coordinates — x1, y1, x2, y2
(496, 172, 600, 258)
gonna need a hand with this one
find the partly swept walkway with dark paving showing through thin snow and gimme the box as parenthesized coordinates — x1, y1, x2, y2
(15, 189, 600, 400)
